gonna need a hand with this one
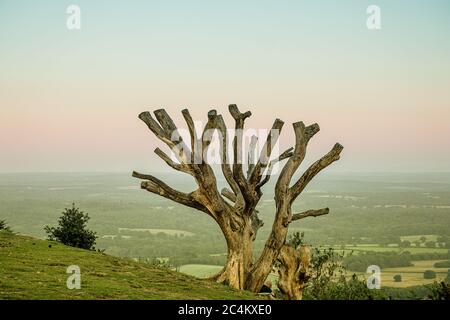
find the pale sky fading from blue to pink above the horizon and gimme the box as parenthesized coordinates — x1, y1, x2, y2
(0, 0, 450, 172)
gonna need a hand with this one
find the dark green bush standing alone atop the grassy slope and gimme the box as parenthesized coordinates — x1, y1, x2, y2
(45, 204, 97, 250)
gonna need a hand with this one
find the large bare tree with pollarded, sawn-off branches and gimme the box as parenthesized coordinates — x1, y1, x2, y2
(133, 105, 343, 292)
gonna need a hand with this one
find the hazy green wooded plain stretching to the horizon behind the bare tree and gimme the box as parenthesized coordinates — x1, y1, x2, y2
(0, 172, 450, 282)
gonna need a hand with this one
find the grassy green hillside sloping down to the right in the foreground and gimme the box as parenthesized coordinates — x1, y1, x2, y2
(0, 231, 255, 299)
